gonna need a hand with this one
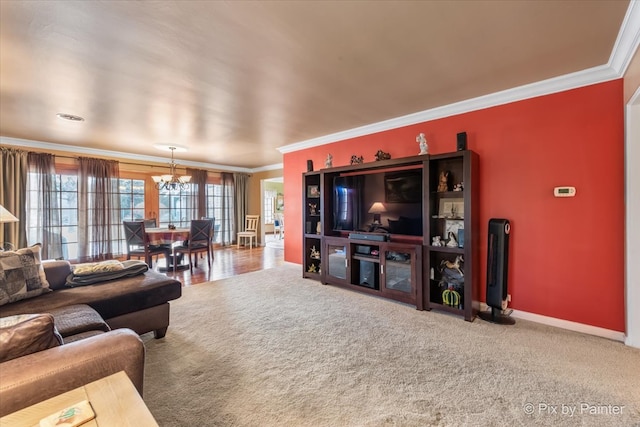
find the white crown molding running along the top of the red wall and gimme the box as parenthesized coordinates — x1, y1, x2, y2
(278, 0, 640, 154)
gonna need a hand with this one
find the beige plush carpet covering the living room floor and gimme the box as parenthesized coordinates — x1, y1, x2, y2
(143, 264, 640, 426)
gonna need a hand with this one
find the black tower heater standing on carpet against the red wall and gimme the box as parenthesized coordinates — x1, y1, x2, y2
(478, 218, 516, 325)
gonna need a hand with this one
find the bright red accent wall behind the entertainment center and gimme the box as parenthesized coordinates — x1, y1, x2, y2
(284, 79, 625, 331)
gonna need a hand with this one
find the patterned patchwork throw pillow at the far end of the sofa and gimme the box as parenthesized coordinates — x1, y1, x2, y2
(0, 244, 51, 305)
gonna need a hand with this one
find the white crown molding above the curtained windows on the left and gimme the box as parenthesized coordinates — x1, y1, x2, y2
(0, 136, 252, 173)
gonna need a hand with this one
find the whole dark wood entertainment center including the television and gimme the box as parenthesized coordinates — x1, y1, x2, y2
(302, 150, 480, 321)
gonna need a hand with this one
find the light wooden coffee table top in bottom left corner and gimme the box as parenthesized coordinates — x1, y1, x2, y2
(0, 371, 158, 427)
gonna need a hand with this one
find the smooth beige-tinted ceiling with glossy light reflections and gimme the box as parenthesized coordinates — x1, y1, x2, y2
(0, 0, 629, 168)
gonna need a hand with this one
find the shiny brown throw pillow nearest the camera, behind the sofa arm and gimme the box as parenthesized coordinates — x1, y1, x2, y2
(0, 314, 62, 363)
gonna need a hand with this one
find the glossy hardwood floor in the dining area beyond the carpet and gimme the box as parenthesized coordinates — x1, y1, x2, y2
(154, 239, 284, 286)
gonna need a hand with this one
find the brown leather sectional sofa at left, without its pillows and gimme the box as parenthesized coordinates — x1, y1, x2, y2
(0, 261, 182, 416)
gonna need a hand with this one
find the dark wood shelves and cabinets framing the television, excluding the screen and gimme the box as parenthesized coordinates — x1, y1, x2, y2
(302, 150, 479, 321)
